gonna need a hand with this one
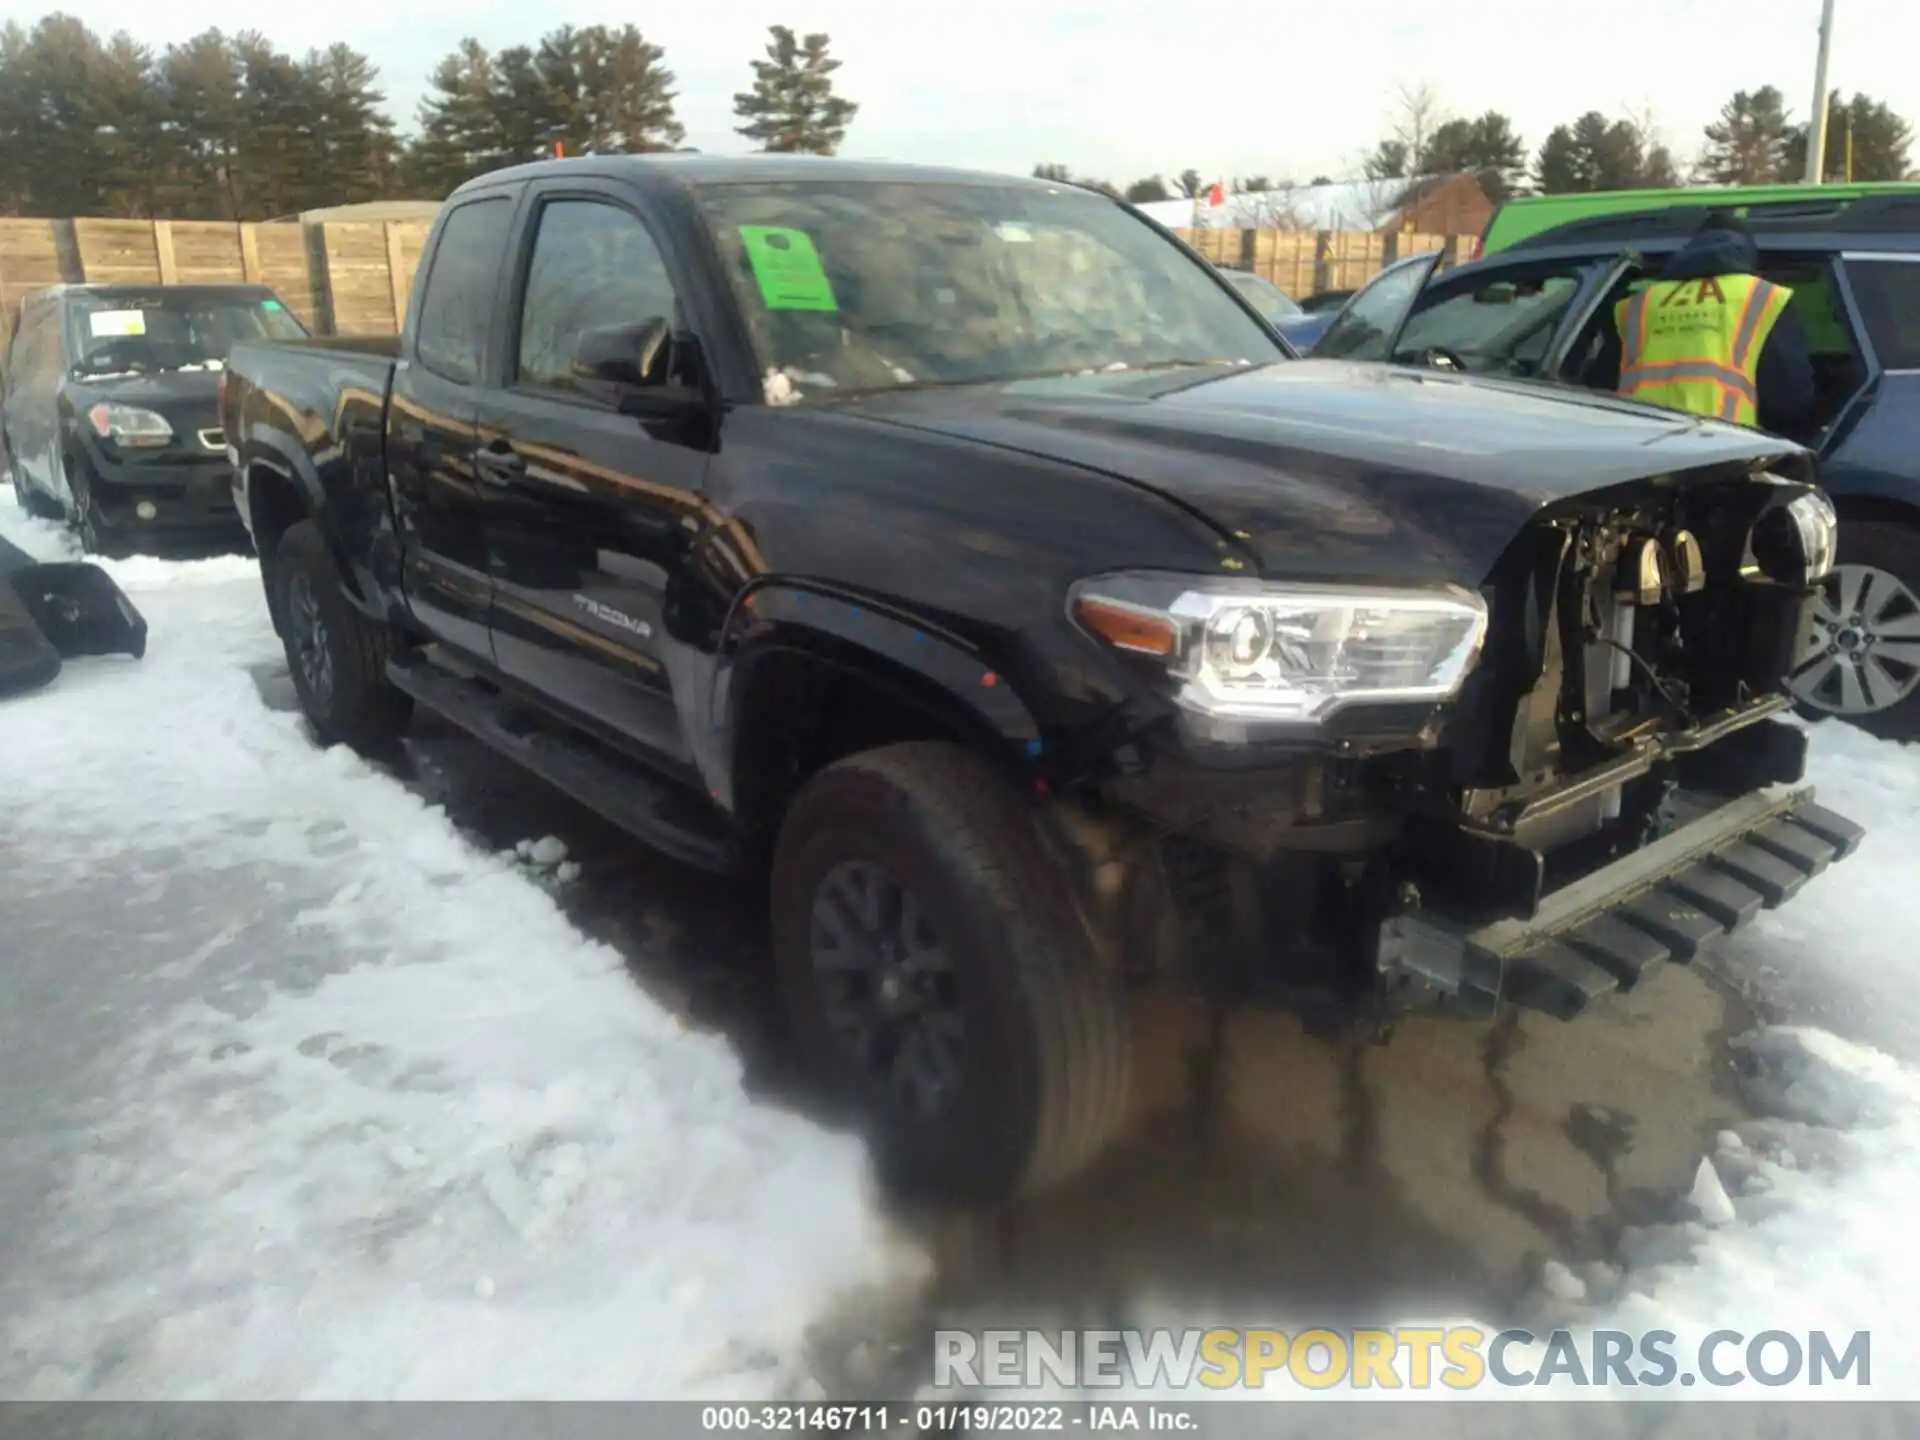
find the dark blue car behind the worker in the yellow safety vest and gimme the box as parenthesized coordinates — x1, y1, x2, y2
(1313, 196, 1920, 739)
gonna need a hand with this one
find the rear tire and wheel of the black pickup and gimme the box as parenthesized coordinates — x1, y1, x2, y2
(273, 520, 413, 753)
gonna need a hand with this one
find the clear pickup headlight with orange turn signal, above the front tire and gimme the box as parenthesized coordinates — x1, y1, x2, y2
(1069, 574, 1486, 724)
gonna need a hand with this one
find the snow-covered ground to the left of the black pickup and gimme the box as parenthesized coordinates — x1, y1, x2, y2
(0, 497, 924, 1400)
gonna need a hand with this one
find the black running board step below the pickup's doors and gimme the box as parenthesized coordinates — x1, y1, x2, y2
(386, 657, 735, 872)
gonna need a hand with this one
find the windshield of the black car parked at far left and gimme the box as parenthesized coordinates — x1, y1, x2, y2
(67, 290, 307, 378)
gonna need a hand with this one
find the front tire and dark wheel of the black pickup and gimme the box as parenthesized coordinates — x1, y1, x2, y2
(772, 743, 1133, 1204)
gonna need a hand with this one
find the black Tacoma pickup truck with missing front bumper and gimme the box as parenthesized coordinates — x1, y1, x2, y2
(223, 156, 1860, 1198)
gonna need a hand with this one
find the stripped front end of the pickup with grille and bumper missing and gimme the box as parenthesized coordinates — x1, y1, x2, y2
(1068, 472, 1862, 1018)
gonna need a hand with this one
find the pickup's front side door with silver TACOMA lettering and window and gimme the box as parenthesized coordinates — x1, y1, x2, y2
(476, 182, 708, 770)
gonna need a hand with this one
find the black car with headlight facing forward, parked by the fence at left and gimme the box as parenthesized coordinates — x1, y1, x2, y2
(4, 284, 307, 555)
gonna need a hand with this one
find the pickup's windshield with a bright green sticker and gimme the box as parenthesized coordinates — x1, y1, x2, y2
(699, 182, 1288, 399)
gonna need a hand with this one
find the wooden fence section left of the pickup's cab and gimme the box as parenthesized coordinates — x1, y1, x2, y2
(0, 219, 428, 340)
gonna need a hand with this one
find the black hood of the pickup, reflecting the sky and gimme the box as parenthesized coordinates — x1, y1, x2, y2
(843, 361, 1805, 586)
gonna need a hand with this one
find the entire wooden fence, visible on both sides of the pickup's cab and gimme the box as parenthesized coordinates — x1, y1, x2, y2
(0, 219, 1473, 344)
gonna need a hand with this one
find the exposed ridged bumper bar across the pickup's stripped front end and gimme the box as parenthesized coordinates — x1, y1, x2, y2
(1380, 785, 1864, 1020)
